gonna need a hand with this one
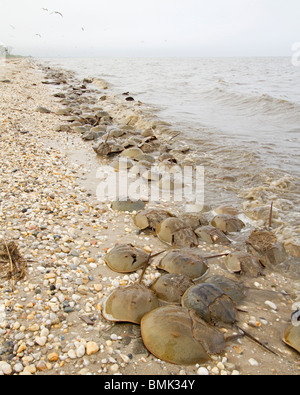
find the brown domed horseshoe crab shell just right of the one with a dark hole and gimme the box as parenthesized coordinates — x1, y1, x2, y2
(157, 250, 208, 279)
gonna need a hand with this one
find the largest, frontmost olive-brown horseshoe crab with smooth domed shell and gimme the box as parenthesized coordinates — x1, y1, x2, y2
(141, 306, 226, 365)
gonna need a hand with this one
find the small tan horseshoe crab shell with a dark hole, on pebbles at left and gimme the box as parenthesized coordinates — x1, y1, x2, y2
(104, 244, 148, 273)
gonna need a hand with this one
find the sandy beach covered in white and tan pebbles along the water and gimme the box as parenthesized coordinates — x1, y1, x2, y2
(0, 59, 300, 376)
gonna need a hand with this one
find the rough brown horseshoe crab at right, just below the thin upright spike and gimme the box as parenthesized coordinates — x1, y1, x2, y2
(246, 230, 285, 266)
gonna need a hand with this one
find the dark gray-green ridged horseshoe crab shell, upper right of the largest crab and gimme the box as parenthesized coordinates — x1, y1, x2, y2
(181, 283, 237, 325)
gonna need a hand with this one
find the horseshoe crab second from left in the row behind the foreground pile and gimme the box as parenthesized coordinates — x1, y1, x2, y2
(156, 218, 198, 247)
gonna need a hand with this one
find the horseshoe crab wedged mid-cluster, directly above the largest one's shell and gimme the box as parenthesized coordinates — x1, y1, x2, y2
(150, 273, 194, 304)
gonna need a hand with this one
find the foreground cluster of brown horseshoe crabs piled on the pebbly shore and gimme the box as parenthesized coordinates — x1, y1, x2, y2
(102, 209, 300, 365)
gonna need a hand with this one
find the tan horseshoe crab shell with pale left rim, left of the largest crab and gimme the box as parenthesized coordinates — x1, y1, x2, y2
(102, 284, 159, 324)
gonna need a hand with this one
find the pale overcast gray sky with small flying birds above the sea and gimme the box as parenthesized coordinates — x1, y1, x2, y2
(0, 0, 300, 57)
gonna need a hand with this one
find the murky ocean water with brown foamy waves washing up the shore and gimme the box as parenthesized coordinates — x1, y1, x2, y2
(43, 58, 300, 245)
